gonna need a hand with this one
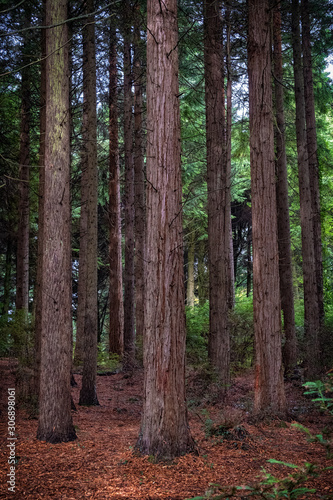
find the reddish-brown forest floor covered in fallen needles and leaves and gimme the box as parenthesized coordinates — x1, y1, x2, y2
(0, 359, 333, 500)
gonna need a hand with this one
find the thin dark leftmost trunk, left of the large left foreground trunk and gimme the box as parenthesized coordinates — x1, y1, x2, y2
(16, 7, 31, 315)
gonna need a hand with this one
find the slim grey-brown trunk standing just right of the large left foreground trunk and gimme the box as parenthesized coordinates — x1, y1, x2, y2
(77, 0, 99, 405)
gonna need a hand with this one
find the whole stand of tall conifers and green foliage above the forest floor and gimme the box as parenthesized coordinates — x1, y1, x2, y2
(0, 0, 333, 456)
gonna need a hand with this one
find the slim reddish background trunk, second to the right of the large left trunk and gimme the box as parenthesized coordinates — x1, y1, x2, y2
(109, 24, 124, 356)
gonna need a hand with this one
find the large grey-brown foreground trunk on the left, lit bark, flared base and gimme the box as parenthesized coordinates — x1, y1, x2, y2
(37, 0, 76, 443)
